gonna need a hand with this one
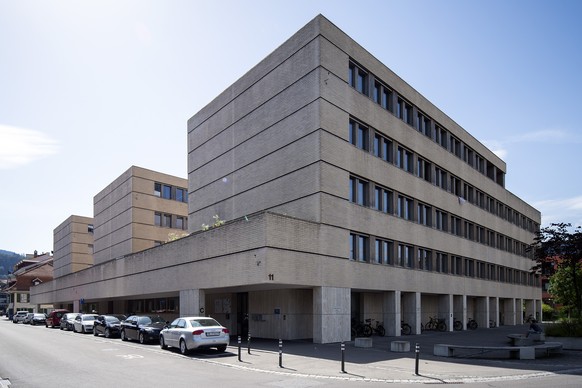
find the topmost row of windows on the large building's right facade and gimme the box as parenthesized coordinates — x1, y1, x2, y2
(348, 61, 505, 186)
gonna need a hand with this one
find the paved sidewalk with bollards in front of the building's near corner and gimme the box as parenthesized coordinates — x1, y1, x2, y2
(200, 325, 582, 383)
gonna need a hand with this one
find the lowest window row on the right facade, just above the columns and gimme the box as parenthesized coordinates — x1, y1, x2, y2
(349, 232, 538, 287)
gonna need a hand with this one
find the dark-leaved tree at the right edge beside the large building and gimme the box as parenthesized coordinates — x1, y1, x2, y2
(532, 223, 582, 317)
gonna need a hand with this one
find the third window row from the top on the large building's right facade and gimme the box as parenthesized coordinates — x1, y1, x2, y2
(349, 176, 533, 259)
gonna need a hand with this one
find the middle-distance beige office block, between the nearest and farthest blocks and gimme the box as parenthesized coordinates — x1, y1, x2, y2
(93, 166, 188, 264)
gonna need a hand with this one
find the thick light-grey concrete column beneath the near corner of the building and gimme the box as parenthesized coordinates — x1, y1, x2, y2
(313, 287, 351, 344)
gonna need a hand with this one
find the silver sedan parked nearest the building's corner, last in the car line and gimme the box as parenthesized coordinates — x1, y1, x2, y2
(160, 317, 230, 354)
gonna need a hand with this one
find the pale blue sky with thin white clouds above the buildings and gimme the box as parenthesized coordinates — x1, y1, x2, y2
(0, 0, 582, 253)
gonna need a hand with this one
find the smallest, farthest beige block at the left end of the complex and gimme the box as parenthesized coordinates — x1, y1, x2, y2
(53, 215, 93, 278)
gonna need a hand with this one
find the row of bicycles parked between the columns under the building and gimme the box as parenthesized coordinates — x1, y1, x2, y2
(351, 317, 497, 338)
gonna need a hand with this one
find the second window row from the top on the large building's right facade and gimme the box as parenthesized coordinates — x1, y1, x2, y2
(348, 118, 539, 233)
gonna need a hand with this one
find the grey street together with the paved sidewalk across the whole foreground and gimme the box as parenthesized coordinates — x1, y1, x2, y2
(0, 317, 582, 388)
